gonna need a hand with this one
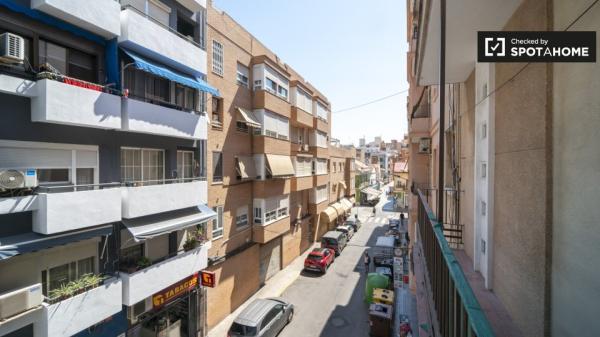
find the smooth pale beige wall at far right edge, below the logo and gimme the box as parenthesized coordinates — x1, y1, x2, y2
(548, 0, 600, 336)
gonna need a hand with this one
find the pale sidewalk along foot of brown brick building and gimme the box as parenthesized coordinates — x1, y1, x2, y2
(207, 243, 318, 337)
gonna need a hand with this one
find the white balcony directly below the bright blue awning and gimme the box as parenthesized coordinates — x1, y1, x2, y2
(121, 98, 207, 139)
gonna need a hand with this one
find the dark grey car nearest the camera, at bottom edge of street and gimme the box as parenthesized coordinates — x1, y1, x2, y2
(227, 297, 294, 337)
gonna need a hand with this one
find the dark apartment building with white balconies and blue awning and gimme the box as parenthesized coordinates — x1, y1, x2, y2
(0, 0, 219, 337)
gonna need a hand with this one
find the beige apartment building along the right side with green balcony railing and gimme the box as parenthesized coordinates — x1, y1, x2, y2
(407, 0, 600, 336)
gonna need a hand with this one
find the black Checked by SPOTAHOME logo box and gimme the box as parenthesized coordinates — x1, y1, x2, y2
(477, 32, 596, 62)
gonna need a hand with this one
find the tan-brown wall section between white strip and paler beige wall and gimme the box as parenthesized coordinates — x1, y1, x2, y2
(490, 0, 548, 336)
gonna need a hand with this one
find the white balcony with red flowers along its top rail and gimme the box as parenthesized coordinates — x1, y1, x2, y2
(31, 74, 121, 129)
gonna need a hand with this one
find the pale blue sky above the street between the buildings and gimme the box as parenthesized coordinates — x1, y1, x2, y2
(214, 0, 408, 144)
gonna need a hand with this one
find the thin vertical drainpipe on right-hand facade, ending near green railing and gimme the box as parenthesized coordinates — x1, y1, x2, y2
(437, 0, 446, 223)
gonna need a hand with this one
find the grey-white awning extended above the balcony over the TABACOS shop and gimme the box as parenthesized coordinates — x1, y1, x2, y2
(123, 205, 217, 242)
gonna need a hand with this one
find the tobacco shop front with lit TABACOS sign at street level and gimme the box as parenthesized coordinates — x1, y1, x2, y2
(127, 273, 204, 337)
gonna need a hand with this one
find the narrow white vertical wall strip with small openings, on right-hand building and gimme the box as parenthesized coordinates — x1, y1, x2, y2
(473, 64, 495, 289)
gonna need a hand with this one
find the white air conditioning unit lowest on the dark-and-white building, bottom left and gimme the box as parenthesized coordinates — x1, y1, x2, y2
(0, 283, 42, 320)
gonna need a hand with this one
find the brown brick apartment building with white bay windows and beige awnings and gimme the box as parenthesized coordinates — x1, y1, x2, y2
(207, 1, 354, 328)
